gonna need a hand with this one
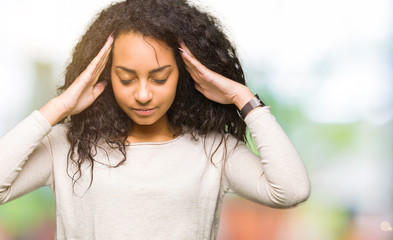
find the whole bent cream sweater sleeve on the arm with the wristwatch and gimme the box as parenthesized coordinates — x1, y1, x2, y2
(224, 106, 311, 208)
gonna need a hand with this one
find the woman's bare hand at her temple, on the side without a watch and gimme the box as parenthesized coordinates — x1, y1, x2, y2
(39, 35, 114, 126)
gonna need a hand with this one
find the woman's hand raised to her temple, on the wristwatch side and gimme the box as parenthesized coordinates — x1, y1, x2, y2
(180, 43, 254, 109)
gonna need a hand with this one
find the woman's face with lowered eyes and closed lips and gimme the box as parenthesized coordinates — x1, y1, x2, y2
(111, 33, 179, 128)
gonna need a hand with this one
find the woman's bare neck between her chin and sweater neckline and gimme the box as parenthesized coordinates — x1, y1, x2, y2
(127, 116, 176, 143)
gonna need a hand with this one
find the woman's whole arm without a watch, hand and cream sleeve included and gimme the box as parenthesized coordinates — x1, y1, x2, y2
(0, 35, 113, 203)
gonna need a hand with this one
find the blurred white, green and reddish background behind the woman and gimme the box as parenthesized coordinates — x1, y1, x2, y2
(0, 0, 393, 240)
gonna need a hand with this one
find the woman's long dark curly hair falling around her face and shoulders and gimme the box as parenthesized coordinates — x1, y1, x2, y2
(58, 0, 246, 195)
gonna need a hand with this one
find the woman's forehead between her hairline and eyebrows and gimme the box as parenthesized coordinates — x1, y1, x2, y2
(112, 32, 175, 70)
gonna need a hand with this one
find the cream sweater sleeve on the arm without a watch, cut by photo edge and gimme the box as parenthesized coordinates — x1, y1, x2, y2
(0, 111, 53, 204)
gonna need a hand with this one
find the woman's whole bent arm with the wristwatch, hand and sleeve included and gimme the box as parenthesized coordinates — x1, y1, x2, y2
(180, 43, 310, 207)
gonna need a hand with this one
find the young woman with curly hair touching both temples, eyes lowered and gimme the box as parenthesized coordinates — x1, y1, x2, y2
(0, 0, 310, 239)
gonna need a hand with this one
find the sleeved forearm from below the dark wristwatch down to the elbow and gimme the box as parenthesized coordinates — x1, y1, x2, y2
(245, 106, 310, 207)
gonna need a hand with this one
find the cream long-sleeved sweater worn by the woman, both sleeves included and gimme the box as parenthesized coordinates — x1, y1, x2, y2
(0, 106, 310, 240)
